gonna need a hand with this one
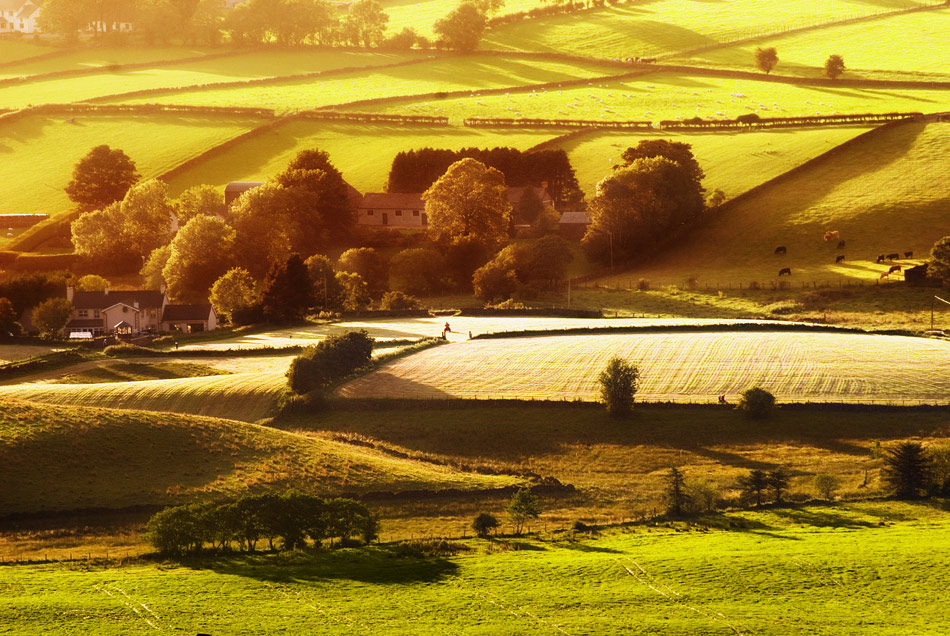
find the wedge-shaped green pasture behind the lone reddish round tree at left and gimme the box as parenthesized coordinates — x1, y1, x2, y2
(0, 114, 261, 222)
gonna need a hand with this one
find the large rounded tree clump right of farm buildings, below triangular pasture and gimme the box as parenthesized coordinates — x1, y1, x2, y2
(581, 139, 706, 267)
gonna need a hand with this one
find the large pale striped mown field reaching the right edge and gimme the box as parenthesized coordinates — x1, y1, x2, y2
(337, 332, 950, 404)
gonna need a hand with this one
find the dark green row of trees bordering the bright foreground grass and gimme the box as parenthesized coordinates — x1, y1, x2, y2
(147, 492, 379, 556)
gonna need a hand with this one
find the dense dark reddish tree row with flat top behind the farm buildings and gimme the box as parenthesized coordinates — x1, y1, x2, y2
(386, 147, 584, 209)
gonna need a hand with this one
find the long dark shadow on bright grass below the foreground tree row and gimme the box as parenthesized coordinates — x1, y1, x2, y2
(181, 547, 458, 585)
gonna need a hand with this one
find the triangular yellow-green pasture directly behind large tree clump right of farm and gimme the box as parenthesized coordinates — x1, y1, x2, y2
(559, 126, 869, 197)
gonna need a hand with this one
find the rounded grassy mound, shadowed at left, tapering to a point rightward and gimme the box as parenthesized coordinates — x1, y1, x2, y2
(0, 401, 517, 513)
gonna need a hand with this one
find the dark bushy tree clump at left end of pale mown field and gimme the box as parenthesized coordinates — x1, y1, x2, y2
(287, 331, 373, 395)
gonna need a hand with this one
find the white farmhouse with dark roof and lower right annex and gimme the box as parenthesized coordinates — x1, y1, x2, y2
(65, 287, 218, 337)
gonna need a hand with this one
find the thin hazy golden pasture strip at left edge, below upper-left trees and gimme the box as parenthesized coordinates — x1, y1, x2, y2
(0, 46, 221, 79)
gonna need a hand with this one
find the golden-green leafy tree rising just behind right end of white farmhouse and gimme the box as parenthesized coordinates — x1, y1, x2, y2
(162, 214, 234, 303)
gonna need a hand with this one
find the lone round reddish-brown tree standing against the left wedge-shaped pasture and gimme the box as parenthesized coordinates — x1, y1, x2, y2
(64, 145, 139, 210)
